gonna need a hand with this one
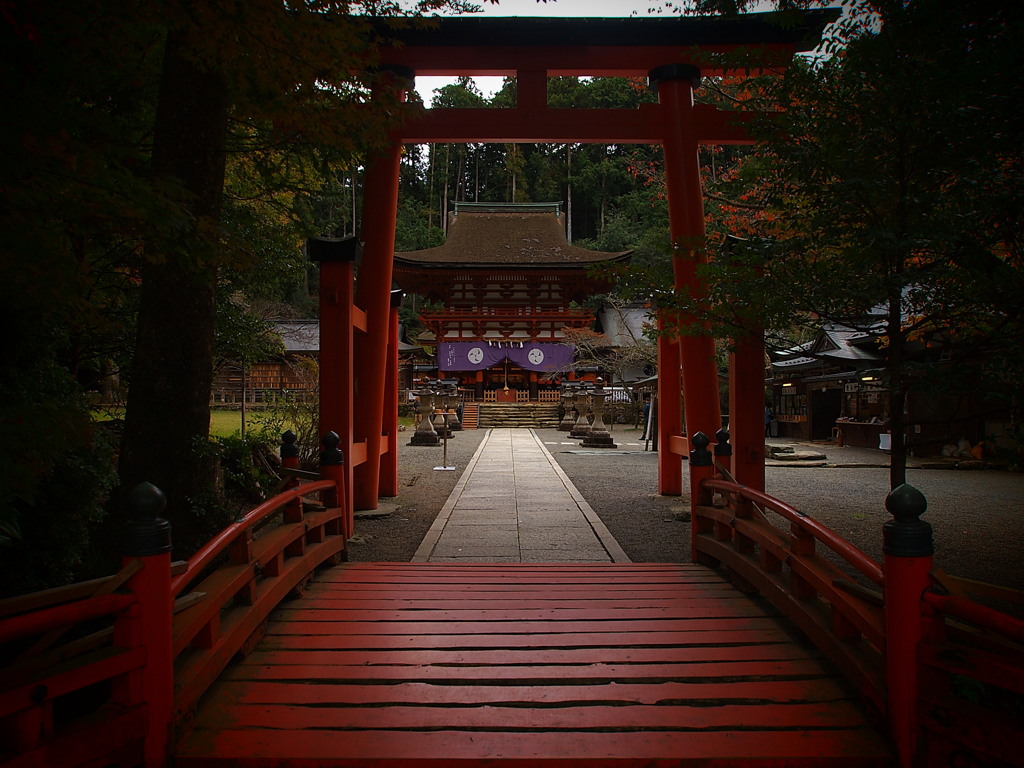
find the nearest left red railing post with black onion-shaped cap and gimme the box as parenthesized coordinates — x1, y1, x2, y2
(114, 482, 174, 768)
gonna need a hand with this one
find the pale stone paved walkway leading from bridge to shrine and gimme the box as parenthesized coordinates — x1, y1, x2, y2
(413, 429, 630, 562)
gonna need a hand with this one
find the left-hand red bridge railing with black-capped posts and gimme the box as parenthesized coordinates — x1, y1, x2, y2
(0, 433, 345, 768)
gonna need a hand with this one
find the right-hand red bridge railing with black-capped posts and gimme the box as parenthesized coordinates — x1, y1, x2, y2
(689, 431, 1024, 768)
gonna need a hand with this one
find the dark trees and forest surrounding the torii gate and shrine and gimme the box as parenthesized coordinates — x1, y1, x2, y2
(0, 0, 1024, 593)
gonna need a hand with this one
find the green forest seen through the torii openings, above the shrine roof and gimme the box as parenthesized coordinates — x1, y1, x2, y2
(396, 77, 666, 274)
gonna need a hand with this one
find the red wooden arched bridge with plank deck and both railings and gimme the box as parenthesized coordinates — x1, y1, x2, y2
(0, 433, 1024, 768)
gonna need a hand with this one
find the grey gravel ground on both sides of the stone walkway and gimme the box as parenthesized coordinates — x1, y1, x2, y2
(349, 428, 1024, 589)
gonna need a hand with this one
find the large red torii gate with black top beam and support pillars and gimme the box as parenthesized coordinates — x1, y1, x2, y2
(321, 9, 839, 524)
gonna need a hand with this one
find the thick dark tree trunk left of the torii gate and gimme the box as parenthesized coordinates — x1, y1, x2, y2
(120, 33, 227, 542)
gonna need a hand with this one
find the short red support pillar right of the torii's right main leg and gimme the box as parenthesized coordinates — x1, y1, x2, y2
(729, 329, 765, 490)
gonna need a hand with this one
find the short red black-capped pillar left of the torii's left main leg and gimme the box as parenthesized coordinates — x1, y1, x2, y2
(306, 238, 358, 528)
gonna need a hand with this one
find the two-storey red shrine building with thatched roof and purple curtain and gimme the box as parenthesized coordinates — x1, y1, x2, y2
(394, 203, 632, 402)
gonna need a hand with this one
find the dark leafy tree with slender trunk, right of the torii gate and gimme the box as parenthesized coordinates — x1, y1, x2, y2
(683, 0, 1024, 484)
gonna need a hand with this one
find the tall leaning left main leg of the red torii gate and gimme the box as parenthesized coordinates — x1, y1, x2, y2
(352, 70, 413, 509)
